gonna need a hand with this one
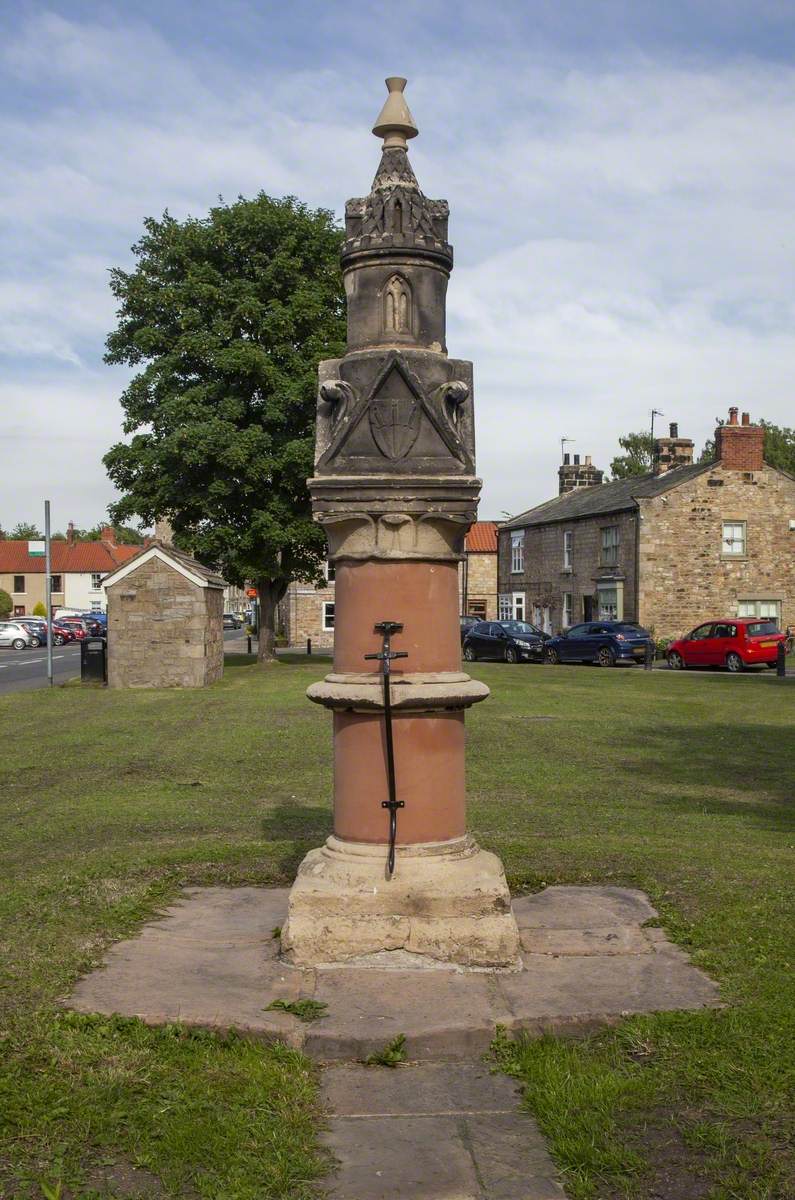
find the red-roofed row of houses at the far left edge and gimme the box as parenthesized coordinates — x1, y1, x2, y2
(0, 522, 141, 617)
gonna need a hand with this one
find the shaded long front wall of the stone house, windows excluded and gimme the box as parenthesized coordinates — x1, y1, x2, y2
(498, 511, 636, 634)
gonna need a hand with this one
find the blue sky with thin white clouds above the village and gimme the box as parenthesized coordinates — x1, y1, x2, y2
(0, 0, 795, 529)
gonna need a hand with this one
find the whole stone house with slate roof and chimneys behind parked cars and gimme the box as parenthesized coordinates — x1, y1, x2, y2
(498, 408, 795, 637)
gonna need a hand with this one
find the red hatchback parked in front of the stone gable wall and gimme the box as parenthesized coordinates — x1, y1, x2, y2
(668, 617, 785, 671)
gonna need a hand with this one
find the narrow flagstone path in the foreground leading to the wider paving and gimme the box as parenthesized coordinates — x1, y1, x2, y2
(322, 1063, 564, 1200)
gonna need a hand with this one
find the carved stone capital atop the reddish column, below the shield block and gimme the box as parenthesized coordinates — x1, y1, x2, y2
(309, 475, 480, 562)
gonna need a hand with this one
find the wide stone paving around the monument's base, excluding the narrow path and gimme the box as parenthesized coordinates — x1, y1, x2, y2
(68, 887, 717, 1061)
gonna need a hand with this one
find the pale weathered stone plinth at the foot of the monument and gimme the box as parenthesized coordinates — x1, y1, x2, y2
(281, 836, 520, 967)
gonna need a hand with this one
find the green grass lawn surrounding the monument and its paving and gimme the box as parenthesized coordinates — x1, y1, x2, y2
(0, 659, 795, 1200)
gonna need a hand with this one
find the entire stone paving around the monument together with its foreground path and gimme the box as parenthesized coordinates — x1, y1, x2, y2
(68, 887, 717, 1200)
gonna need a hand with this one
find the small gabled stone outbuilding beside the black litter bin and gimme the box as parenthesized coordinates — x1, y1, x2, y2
(104, 541, 226, 688)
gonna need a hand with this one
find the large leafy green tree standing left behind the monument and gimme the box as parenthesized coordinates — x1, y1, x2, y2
(104, 193, 345, 660)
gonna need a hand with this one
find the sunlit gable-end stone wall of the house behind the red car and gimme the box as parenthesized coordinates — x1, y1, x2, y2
(639, 463, 795, 637)
